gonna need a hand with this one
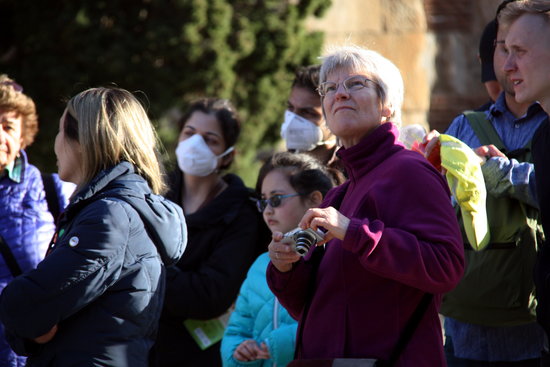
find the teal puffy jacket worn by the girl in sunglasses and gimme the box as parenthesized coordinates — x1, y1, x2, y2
(221, 252, 297, 367)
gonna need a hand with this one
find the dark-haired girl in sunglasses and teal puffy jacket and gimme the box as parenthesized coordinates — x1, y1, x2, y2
(221, 152, 334, 366)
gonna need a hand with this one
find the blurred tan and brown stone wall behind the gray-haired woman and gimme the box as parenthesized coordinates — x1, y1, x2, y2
(308, 0, 501, 131)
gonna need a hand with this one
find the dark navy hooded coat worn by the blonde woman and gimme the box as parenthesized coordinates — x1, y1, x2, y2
(0, 162, 186, 367)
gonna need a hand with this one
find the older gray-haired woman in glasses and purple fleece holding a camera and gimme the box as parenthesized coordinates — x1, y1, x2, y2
(267, 46, 464, 367)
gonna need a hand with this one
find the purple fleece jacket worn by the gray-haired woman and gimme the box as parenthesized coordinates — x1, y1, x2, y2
(267, 123, 464, 367)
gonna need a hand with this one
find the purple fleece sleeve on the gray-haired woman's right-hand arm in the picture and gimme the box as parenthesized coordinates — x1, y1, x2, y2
(342, 160, 464, 293)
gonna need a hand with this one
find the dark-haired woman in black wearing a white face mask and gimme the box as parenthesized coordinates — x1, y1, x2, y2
(151, 99, 269, 367)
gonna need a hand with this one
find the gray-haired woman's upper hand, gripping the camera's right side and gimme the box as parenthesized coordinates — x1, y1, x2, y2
(299, 206, 350, 246)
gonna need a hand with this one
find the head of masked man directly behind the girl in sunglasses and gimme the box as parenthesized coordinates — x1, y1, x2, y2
(281, 65, 340, 170)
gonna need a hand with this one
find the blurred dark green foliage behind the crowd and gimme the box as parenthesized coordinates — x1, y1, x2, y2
(0, 0, 331, 185)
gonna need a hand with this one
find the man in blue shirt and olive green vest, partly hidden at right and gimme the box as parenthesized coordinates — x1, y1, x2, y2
(426, 1, 546, 367)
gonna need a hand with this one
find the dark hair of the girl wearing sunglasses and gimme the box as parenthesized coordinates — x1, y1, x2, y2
(256, 152, 335, 197)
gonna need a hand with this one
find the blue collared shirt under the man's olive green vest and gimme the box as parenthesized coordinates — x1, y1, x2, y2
(445, 93, 547, 361)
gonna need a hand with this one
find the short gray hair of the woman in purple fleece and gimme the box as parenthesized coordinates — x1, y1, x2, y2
(319, 45, 404, 126)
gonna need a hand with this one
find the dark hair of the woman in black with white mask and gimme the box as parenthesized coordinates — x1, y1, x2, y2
(178, 98, 241, 169)
